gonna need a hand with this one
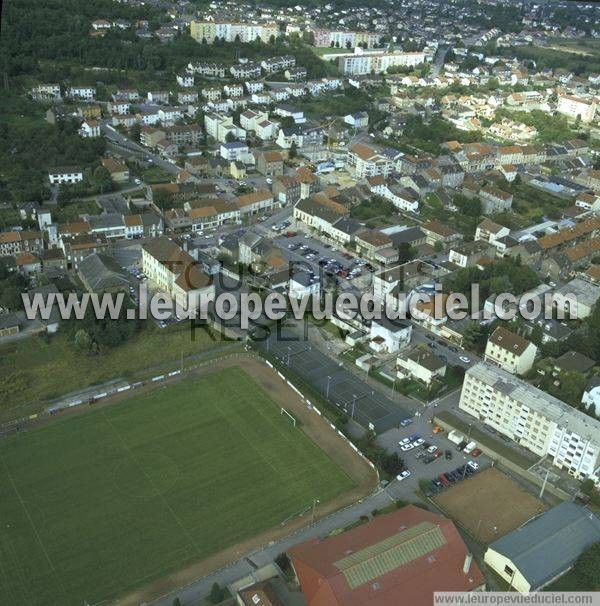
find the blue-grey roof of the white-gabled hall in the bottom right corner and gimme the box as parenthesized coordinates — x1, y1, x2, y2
(489, 502, 600, 590)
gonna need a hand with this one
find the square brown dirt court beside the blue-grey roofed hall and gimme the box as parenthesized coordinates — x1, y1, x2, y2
(433, 468, 547, 545)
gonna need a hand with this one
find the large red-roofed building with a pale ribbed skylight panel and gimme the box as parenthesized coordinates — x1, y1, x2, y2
(288, 505, 485, 606)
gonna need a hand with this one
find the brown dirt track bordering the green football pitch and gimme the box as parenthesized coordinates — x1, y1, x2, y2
(94, 355, 378, 606)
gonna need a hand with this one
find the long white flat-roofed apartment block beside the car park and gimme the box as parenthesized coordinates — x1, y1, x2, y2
(459, 362, 600, 484)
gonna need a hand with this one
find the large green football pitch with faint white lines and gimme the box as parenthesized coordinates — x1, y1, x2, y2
(0, 367, 353, 606)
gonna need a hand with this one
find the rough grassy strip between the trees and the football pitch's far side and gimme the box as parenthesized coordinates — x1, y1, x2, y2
(0, 322, 229, 411)
